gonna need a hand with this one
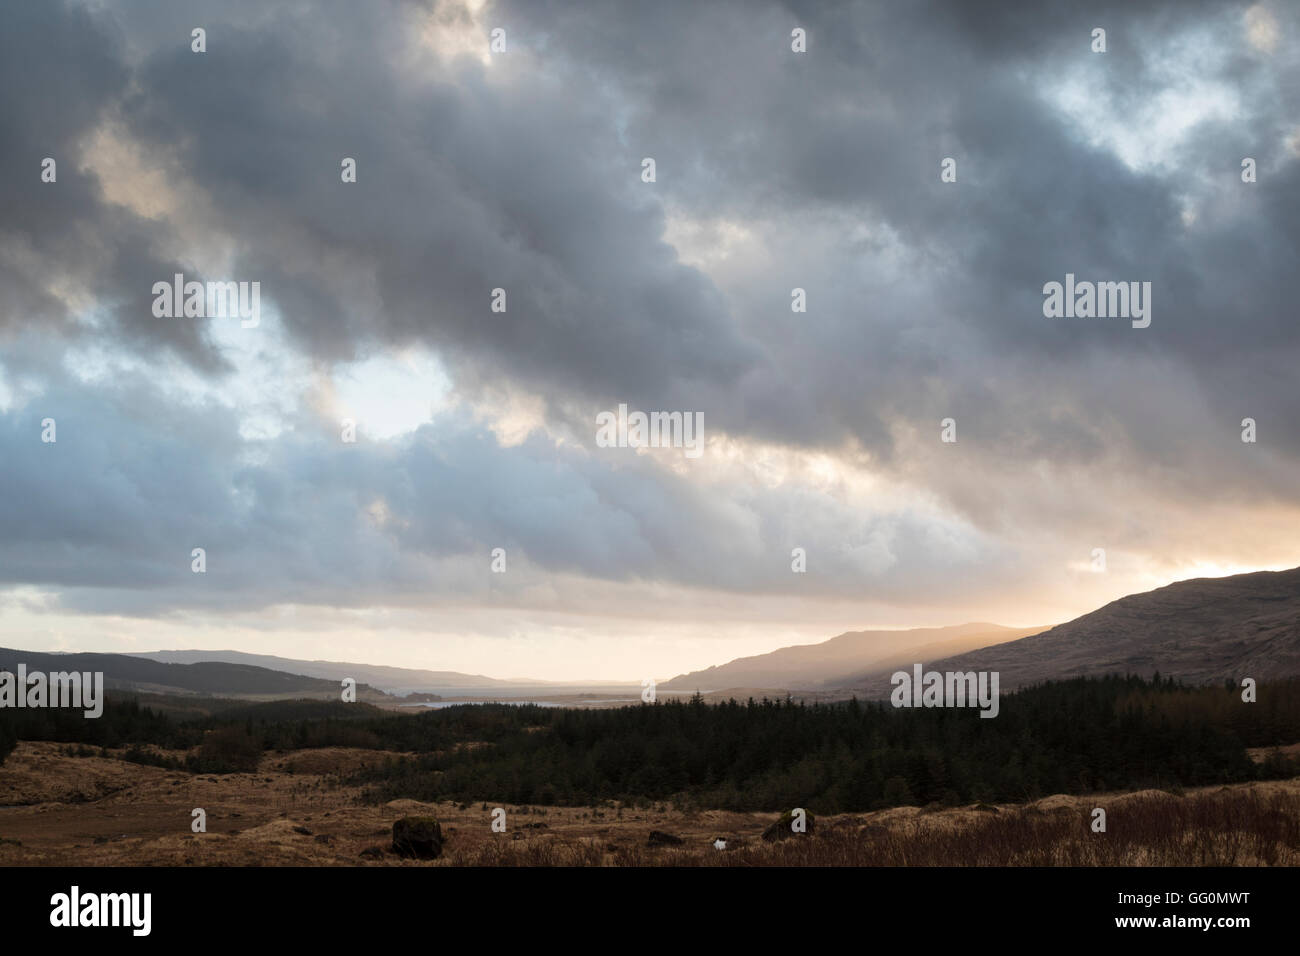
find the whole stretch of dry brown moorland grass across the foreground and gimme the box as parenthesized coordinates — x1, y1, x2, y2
(0, 743, 1300, 866)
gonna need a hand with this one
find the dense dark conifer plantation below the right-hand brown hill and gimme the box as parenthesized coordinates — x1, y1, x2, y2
(353, 678, 1300, 813)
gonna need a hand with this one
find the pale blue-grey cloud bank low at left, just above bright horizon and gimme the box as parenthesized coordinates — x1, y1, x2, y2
(0, 366, 1001, 613)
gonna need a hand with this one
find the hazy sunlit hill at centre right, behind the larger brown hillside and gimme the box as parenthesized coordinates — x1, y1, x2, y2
(659, 623, 1044, 692)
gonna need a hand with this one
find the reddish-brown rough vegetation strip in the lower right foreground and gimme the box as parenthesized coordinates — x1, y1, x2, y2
(431, 784, 1300, 866)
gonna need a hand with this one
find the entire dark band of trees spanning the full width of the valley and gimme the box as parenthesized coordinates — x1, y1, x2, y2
(0, 678, 1300, 813)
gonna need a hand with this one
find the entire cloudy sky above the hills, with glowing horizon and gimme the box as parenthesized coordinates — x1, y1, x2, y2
(0, 0, 1300, 680)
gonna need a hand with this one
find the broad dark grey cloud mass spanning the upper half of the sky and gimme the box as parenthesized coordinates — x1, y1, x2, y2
(12, 4, 1300, 454)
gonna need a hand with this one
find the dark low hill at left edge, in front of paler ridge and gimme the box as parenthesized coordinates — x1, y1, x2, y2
(0, 648, 386, 700)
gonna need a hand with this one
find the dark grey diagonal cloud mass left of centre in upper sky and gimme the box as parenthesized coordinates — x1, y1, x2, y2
(104, 5, 757, 397)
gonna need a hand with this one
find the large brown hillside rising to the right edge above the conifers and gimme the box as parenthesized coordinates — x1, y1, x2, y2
(852, 568, 1300, 698)
